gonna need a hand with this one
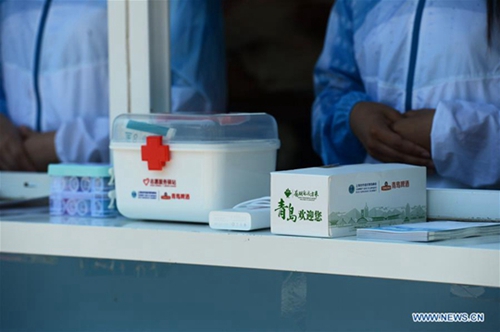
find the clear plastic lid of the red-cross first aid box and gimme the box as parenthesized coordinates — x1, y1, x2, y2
(111, 113, 279, 145)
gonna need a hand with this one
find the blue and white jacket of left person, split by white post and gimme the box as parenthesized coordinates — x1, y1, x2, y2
(0, 0, 226, 162)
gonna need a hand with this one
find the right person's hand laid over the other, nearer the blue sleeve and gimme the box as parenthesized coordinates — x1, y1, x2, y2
(350, 102, 433, 168)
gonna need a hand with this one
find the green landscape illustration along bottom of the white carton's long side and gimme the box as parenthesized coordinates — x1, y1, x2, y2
(328, 203, 426, 227)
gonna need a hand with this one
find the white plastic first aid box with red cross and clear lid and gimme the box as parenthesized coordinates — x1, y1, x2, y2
(110, 113, 280, 223)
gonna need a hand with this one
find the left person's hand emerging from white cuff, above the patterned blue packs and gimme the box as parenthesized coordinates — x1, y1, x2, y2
(19, 127, 59, 172)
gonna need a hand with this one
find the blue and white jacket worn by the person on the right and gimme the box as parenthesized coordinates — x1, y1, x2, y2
(312, 0, 500, 188)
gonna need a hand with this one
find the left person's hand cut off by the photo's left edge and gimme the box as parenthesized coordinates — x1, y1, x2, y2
(0, 114, 35, 172)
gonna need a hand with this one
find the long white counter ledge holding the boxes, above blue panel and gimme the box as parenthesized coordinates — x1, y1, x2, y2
(0, 213, 500, 287)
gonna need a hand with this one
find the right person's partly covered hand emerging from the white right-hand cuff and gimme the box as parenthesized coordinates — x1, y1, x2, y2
(392, 109, 436, 152)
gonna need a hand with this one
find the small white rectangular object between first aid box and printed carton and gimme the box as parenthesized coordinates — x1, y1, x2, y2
(208, 208, 271, 231)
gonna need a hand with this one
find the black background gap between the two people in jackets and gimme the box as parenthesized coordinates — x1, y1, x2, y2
(224, 0, 334, 170)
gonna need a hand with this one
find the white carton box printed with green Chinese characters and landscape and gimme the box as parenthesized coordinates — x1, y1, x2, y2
(271, 164, 427, 237)
